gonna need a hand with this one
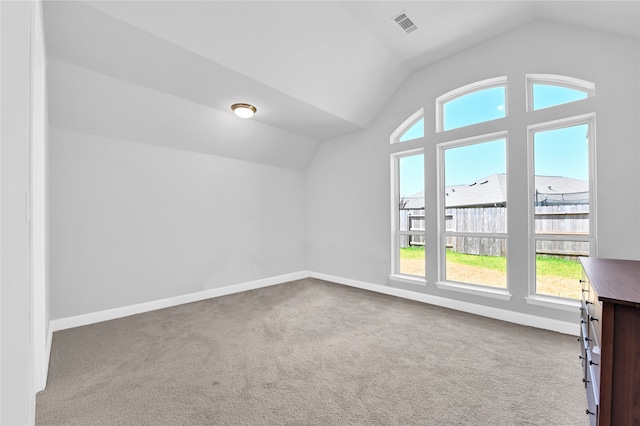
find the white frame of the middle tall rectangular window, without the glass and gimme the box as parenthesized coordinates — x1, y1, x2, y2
(436, 130, 511, 300)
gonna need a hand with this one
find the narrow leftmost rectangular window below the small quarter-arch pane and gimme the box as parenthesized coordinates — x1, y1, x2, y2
(392, 150, 425, 278)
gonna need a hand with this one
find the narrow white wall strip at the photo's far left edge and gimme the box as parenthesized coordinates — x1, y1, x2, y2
(0, 1, 35, 425)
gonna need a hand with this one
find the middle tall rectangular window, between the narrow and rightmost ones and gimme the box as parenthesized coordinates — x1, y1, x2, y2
(440, 133, 507, 288)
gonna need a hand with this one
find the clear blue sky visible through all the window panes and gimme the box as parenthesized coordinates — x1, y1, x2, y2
(400, 85, 589, 196)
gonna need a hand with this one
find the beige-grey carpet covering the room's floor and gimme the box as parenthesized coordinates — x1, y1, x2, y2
(36, 278, 588, 426)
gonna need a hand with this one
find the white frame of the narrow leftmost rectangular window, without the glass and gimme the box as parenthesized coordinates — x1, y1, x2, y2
(389, 148, 427, 284)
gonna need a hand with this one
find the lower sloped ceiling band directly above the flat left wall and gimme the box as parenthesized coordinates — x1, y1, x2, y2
(45, 57, 320, 170)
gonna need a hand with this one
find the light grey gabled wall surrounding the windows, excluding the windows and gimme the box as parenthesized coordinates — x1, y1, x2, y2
(307, 22, 640, 321)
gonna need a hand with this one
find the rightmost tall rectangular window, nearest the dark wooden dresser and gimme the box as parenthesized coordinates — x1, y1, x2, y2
(529, 117, 593, 299)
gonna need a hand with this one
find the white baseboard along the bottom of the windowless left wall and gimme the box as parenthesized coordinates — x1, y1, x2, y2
(49, 271, 309, 333)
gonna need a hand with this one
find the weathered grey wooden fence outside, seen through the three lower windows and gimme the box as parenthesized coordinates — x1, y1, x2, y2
(400, 204, 589, 257)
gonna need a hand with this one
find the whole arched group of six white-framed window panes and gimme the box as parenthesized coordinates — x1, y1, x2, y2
(391, 74, 596, 302)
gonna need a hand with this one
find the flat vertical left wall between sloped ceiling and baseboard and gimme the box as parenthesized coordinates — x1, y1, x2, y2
(50, 129, 306, 319)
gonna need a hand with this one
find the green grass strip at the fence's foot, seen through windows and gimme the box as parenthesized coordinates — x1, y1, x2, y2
(400, 247, 582, 279)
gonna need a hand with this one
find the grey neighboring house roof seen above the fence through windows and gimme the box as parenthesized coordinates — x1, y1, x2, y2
(404, 173, 589, 209)
